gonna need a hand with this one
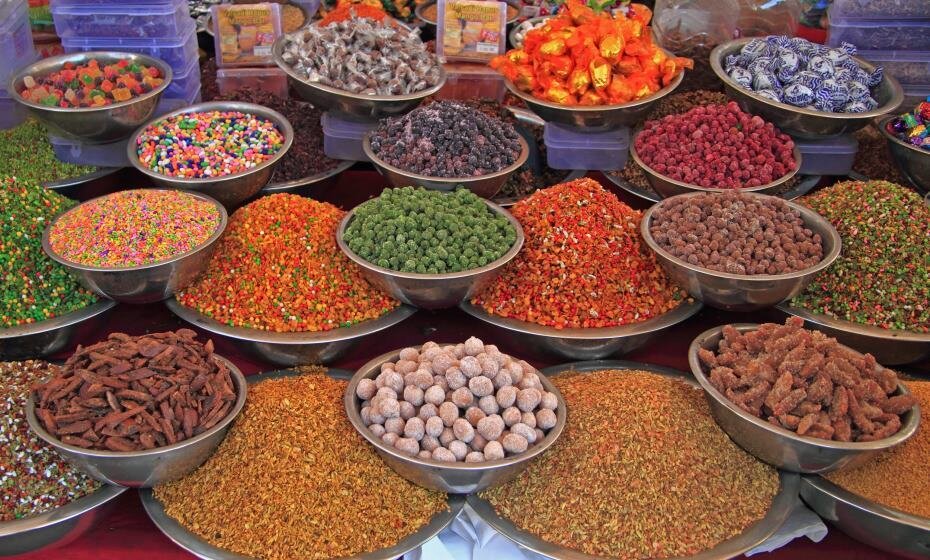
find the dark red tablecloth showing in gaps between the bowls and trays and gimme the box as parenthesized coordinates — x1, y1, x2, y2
(20, 171, 926, 560)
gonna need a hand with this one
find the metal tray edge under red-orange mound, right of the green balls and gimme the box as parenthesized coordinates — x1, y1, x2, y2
(459, 301, 702, 360)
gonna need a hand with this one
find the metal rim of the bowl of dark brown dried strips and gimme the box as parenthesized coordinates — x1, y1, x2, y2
(26, 354, 248, 459)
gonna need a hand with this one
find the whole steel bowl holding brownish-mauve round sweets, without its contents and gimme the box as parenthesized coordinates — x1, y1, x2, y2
(640, 193, 842, 311)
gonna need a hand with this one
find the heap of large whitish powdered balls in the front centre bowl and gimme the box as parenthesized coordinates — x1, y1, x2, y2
(355, 337, 559, 463)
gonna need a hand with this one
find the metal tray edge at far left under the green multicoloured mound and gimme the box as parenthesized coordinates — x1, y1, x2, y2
(0, 299, 116, 360)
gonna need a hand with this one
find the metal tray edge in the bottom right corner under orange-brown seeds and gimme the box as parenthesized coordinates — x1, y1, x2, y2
(801, 475, 930, 560)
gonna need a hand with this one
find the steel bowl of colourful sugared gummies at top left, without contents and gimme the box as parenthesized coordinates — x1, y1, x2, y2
(6, 51, 173, 144)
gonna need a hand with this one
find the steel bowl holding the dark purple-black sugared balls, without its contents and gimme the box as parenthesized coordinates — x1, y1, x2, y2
(362, 133, 530, 198)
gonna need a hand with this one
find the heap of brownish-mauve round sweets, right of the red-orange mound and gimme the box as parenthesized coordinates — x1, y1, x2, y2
(649, 191, 823, 276)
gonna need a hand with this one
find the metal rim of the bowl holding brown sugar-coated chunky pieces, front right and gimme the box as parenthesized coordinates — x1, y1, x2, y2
(688, 323, 920, 452)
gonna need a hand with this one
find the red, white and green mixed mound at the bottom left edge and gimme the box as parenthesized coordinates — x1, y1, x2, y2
(0, 361, 100, 522)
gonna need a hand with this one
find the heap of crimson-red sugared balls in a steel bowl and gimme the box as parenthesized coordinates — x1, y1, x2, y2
(634, 101, 798, 189)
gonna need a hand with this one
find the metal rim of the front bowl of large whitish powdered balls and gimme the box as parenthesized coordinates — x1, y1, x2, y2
(343, 345, 568, 472)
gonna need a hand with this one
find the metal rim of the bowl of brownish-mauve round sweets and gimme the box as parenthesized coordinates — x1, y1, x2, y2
(639, 192, 843, 282)
